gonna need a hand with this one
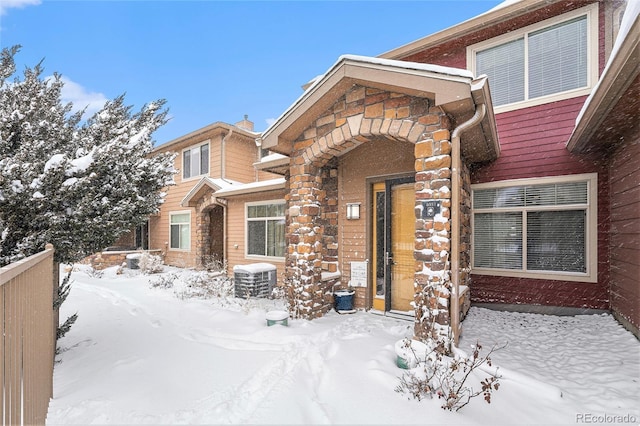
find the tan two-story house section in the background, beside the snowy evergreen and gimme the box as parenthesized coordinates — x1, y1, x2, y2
(148, 116, 284, 267)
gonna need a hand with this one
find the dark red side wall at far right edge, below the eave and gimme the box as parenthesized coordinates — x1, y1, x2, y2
(610, 129, 640, 329)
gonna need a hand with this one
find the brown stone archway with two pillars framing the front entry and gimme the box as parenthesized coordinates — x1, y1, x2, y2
(286, 85, 451, 337)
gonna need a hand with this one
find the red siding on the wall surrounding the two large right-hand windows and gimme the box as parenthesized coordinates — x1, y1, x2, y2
(404, 1, 612, 312)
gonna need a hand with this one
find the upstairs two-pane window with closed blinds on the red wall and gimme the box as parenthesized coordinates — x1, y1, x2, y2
(468, 4, 598, 112)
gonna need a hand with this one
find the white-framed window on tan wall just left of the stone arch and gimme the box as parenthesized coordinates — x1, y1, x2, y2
(247, 202, 285, 257)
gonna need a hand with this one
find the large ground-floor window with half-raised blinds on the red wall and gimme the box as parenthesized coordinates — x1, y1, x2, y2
(472, 174, 597, 282)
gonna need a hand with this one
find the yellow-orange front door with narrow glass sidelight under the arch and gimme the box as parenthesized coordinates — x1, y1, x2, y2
(372, 178, 415, 312)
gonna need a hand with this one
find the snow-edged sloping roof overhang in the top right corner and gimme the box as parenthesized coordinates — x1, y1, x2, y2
(567, 3, 640, 152)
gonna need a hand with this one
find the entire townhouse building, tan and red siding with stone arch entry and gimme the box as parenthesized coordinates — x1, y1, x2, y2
(142, 0, 640, 342)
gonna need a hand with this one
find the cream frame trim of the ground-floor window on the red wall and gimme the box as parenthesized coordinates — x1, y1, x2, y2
(471, 173, 598, 283)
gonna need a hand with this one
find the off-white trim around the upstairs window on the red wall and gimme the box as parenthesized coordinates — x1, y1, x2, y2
(467, 3, 599, 114)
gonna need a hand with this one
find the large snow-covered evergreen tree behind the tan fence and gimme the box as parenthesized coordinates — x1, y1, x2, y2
(0, 47, 175, 266)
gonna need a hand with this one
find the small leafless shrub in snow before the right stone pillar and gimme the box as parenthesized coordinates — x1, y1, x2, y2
(396, 339, 501, 411)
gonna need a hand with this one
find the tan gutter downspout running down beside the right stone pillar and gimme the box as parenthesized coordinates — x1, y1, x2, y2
(451, 104, 487, 346)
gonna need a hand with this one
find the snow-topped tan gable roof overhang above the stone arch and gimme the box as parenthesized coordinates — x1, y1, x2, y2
(261, 55, 498, 161)
